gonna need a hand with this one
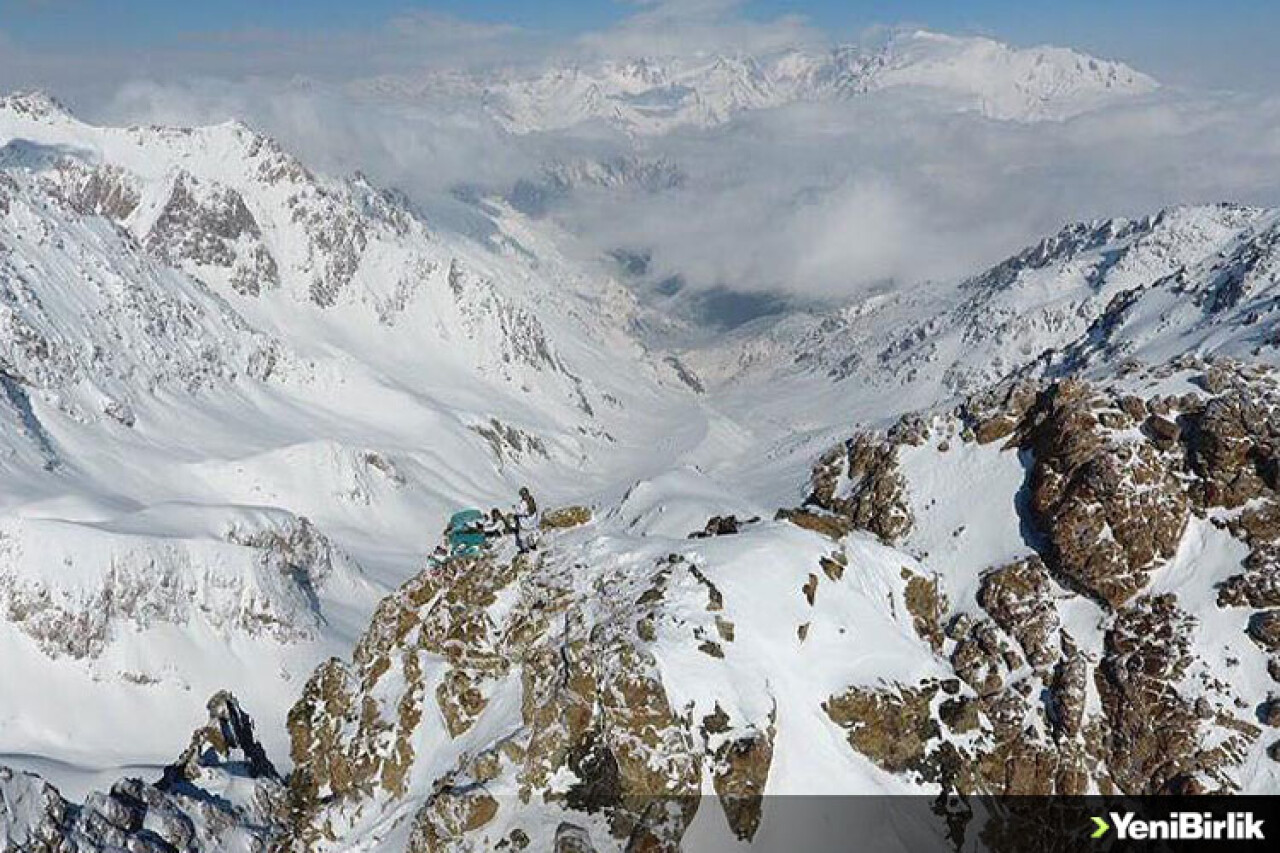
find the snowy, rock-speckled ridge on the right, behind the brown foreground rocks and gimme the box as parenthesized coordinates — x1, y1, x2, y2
(682, 205, 1280, 416)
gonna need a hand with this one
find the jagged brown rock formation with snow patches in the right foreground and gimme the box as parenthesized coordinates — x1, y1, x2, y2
(818, 361, 1280, 794)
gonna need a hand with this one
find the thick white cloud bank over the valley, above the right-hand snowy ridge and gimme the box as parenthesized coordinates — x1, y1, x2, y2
(535, 92, 1280, 297)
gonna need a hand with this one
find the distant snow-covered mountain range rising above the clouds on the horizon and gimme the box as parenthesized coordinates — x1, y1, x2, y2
(361, 31, 1157, 134)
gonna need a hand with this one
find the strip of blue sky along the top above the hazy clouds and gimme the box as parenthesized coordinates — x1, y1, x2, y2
(0, 0, 1280, 88)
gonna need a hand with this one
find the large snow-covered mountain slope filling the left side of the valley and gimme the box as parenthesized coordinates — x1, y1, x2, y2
(0, 95, 689, 790)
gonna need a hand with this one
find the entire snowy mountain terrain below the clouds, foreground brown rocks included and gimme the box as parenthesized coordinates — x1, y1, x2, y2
(0, 84, 1280, 852)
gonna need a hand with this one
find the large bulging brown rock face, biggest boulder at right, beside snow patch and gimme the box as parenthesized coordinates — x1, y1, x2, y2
(1024, 382, 1189, 607)
